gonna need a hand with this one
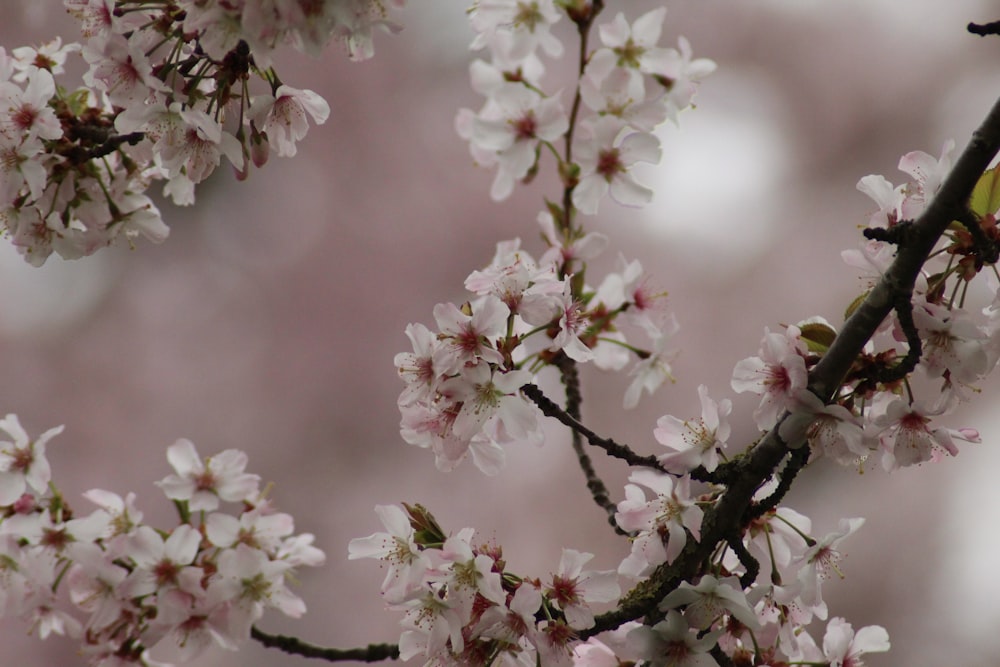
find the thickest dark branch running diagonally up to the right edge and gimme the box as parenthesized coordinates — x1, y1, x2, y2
(580, 92, 1000, 638)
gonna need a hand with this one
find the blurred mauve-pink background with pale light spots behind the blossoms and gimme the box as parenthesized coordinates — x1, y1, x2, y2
(0, 0, 1000, 667)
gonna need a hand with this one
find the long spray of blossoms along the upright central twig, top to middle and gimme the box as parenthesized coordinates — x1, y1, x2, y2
(396, 0, 715, 473)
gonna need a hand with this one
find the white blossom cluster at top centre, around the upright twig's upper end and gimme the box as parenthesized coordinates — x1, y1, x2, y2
(456, 0, 715, 209)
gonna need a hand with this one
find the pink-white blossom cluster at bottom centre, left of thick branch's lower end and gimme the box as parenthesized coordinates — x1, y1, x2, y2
(350, 505, 621, 667)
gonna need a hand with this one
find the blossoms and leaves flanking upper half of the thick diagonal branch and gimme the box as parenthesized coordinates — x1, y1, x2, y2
(720, 142, 1000, 471)
